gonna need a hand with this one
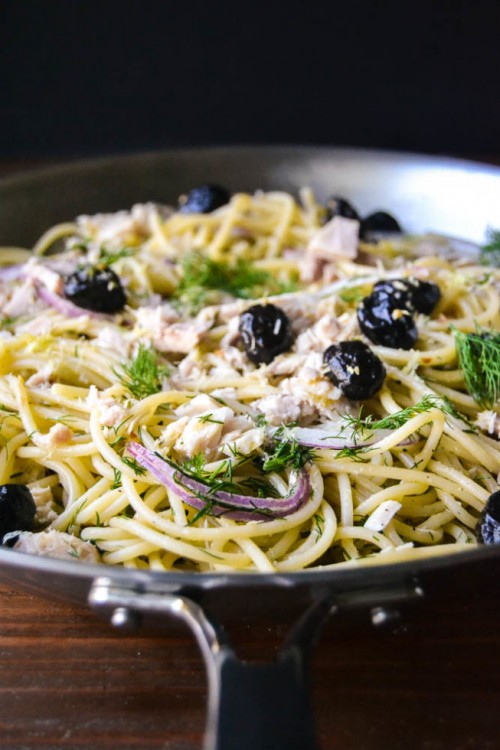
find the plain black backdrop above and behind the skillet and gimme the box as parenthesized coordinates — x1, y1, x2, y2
(0, 0, 500, 159)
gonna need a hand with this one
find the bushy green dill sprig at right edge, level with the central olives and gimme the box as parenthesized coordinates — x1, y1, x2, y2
(455, 329, 500, 408)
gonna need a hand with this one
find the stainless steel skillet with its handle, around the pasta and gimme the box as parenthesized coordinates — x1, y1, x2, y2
(0, 147, 500, 750)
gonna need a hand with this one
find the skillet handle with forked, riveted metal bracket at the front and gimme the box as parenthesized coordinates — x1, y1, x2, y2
(89, 577, 422, 750)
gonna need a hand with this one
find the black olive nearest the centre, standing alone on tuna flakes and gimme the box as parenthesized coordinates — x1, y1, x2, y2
(239, 305, 293, 364)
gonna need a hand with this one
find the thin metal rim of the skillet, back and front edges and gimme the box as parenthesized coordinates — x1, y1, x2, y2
(0, 143, 500, 588)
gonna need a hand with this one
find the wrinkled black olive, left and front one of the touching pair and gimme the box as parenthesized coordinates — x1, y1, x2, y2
(358, 292, 418, 349)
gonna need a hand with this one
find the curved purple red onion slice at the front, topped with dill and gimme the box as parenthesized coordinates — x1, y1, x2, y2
(127, 443, 311, 521)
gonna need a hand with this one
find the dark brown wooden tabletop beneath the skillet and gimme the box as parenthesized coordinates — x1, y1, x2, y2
(0, 160, 500, 750)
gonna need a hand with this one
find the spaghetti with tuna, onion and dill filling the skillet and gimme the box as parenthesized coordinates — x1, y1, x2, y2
(0, 189, 500, 572)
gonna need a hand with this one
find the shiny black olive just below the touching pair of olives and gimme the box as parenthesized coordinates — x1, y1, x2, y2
(323, 341, 385, 401)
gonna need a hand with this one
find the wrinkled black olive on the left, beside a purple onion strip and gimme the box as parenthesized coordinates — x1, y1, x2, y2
(64, 266, 127, 313)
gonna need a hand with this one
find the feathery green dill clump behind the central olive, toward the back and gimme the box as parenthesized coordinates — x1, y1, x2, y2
(174, 252, 294, 311)
